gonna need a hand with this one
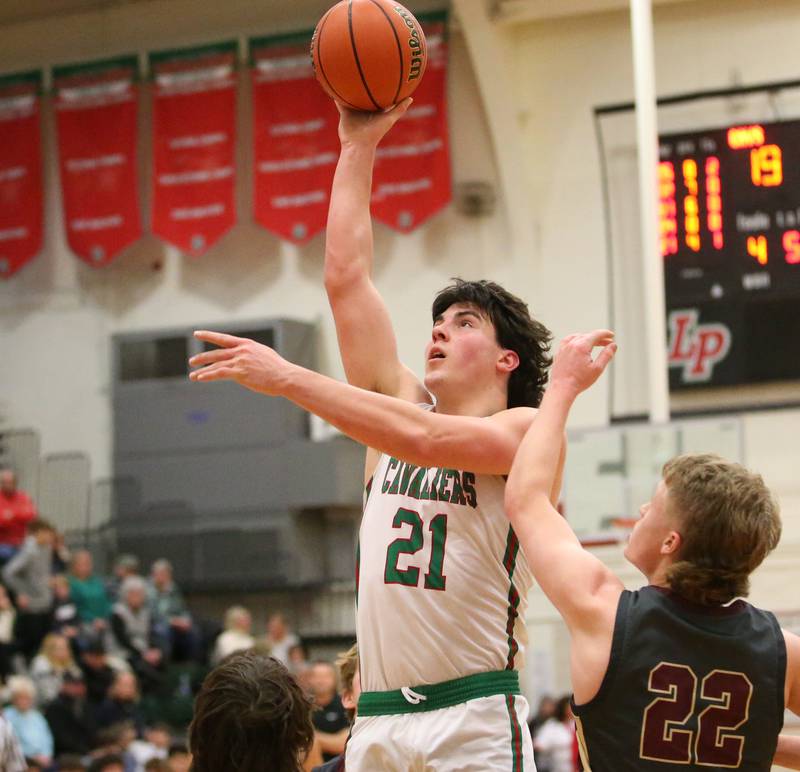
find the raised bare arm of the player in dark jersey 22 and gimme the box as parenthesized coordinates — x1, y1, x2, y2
(505, 331, 623, 634)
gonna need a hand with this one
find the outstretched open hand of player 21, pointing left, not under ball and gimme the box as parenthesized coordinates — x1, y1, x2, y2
(189, 330, 293, 396)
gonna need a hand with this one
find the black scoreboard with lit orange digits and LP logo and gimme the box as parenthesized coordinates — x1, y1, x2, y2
(658, 121, 800, 389)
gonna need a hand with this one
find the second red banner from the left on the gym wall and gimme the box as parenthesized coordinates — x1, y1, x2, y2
(53, 56, 142, 266)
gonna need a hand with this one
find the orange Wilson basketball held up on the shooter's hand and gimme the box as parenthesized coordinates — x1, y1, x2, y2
(311, 0, 427, 112)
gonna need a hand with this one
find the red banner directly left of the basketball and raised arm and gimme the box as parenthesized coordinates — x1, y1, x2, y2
(250, 32, 339, 244)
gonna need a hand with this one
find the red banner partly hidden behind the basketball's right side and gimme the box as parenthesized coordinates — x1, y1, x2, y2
(372, 13, 452, 232)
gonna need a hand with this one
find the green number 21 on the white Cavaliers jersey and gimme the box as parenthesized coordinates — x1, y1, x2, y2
(383, 507, 447, 590)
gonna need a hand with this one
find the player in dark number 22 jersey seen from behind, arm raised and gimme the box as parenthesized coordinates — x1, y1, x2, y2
(506, 331, 800, 772)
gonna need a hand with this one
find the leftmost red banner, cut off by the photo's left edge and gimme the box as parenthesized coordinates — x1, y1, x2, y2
(0, 72, 43, 278)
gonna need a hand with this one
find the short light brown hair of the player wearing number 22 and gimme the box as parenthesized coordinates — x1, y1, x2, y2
(663, 454, 781, 605)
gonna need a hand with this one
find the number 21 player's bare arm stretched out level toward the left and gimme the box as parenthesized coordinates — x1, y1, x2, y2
(190, 331, 548, 476)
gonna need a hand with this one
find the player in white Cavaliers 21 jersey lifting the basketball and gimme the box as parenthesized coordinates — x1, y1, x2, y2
(192, 100, 562, 772)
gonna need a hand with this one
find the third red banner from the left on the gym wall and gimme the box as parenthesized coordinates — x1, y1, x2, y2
(150, 42, 237, 255)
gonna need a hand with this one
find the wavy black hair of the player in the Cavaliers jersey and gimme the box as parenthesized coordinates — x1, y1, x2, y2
(431, 278, 553, 407)
